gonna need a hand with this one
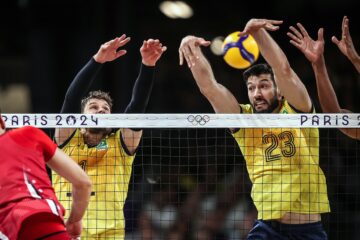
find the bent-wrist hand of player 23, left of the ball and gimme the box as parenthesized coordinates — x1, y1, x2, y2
(179, 36, 211, 68)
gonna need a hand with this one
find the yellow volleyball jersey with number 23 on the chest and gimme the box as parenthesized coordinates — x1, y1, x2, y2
(233, 100, 330, 220)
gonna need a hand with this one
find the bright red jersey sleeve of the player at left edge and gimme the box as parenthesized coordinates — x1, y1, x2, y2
(9, 126, 57, 162)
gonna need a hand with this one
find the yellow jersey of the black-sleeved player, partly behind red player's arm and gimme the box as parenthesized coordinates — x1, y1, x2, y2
(53, 129, 134, 239)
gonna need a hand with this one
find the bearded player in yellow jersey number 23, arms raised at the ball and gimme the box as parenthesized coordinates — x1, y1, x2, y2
(179, 19, 330, 240)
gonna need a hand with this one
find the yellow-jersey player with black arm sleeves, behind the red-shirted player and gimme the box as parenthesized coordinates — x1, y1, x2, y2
(53, 35, 166, 239)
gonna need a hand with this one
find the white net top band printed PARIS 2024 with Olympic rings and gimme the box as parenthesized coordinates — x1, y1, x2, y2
(2, 113, 360, 128)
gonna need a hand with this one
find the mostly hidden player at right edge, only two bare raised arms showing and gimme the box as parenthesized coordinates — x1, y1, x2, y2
(288, 16, 360, 140)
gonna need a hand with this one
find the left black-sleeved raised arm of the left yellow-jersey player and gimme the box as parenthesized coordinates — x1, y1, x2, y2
(55, 34, 130, 145)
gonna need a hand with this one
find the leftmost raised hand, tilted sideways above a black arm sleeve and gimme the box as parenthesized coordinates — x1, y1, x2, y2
(94, 34, 130, 63)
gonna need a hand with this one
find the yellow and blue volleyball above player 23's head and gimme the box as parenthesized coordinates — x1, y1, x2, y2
(222, 32, 259, 69)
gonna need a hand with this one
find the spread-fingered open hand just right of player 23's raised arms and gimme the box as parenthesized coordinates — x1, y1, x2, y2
(287, 23, 325, 63)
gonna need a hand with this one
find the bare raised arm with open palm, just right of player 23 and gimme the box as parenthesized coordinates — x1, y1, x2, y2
(288, 23, 360, 139)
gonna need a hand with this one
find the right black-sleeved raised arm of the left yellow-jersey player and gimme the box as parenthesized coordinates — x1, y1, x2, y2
(121, 39, 166, 154)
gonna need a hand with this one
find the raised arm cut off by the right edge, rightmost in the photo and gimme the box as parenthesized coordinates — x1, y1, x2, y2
(331, 16, 360, 73)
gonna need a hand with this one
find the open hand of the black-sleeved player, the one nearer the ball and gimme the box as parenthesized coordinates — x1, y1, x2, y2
(140, 39, 167, 67)
